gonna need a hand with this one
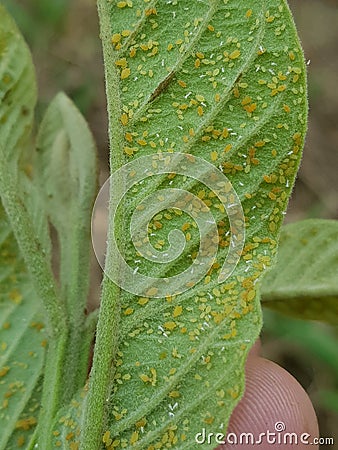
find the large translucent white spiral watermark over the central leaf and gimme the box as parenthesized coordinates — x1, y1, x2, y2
(92, 152, 245, 298)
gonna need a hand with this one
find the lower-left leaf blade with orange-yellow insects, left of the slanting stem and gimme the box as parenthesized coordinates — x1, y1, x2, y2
(0, 207, 46, 450)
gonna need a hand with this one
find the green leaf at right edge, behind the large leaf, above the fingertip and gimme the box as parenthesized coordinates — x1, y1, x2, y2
(262, 219, 338, 324)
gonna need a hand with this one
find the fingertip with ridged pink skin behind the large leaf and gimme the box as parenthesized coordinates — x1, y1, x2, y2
(218, 356, 319, 450)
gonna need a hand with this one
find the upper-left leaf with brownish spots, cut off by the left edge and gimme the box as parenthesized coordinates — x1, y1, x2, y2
(0, 5, 55, 318)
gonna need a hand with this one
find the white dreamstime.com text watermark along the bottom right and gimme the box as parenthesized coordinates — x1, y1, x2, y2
(195, 421, 334, 448)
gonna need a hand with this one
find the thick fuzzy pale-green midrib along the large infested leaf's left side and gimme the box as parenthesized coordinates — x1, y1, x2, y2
(80, 0, 124, 450)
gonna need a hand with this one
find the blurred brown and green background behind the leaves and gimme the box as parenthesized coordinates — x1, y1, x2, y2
(3, 0, 338, 450)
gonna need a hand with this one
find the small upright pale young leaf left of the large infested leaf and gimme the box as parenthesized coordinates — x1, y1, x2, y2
(34, 93, 97, 322)
